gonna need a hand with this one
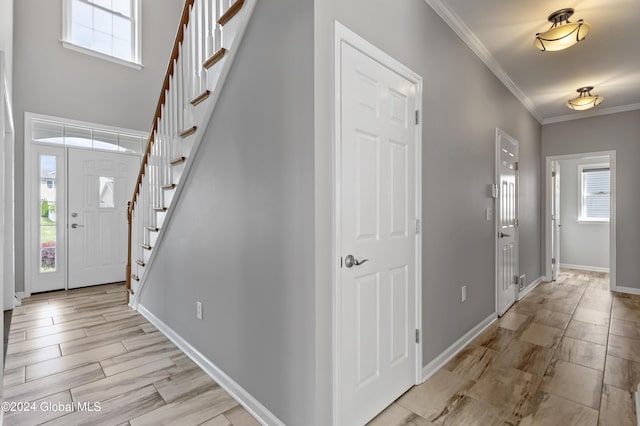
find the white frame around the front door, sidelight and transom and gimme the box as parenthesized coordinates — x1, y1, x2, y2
(24, 112, 148, 297)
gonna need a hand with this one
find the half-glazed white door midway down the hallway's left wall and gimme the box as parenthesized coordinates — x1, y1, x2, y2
(496, 130, 518, 315)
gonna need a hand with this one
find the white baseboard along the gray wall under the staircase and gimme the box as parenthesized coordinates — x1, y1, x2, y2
(138, 304, 284, 426)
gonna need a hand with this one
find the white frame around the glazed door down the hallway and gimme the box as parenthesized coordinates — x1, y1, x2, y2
(493, 128, 520, 315)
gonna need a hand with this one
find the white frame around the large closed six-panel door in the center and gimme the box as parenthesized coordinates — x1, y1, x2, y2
(331, 21, 423, 426)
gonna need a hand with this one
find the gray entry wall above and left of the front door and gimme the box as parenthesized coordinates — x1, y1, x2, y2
(13, 0, 183, 291)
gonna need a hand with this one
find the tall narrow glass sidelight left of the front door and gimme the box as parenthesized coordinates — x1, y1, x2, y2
(39, 155, 58, 272)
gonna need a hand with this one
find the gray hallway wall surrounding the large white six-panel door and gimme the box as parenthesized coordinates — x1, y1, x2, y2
(315, 0, 542, 422)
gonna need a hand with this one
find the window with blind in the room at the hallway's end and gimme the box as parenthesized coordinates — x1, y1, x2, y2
(578, 165, 611, 222)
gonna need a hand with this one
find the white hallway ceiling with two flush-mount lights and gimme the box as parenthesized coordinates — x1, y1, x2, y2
(426, 0, 640, 123)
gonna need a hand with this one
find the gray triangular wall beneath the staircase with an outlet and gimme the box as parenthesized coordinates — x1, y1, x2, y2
(141, 0, 315, 425)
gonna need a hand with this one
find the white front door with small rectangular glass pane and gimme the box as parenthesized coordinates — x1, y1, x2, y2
(67, 148, 140, 288)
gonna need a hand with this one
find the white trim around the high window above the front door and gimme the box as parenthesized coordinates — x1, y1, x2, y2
(60, 0, 144, 70)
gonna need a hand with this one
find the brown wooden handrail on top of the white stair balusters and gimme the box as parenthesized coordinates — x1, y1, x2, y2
(126, 0, 195, 293)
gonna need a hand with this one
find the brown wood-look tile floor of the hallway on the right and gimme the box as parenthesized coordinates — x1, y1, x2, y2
(370, 270, 640, 426)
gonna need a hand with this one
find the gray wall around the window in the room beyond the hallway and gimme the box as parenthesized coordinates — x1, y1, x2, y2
(559, 157, 609, 268)
